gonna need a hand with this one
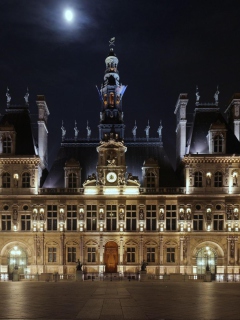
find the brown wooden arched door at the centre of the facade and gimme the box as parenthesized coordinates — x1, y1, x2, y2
(104, 241, 118, 272)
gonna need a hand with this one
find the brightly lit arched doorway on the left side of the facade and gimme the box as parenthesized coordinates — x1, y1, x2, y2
(8, 246, 27, 274)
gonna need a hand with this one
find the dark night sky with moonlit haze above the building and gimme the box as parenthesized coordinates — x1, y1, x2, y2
(0, 0, 240, 169)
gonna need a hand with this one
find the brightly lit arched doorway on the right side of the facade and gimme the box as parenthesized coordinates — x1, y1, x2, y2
(196, 246, 217, 274)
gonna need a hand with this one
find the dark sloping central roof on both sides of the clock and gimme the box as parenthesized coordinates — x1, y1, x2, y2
(43, 138, 179, 188)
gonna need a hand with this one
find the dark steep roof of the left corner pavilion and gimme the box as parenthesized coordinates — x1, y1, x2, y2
(0, 106, 36, 156)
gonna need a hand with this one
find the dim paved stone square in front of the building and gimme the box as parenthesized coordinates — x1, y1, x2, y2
(0, 281, 240, 320)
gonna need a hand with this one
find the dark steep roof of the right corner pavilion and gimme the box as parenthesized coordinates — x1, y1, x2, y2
(187, 106, 240, 154)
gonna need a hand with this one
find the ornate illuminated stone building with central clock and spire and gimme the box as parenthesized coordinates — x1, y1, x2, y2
(0, 48, 240, 275)
